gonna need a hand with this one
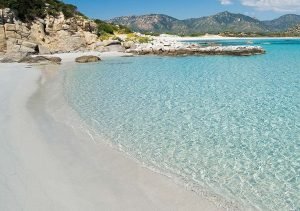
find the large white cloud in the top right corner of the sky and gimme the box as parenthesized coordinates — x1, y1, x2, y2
(241, 0, 300, 12)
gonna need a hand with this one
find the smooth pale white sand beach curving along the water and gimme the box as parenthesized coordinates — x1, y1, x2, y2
(0, 54, 225, 211)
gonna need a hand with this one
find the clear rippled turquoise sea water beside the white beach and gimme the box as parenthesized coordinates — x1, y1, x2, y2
(65, 40, 300, 210)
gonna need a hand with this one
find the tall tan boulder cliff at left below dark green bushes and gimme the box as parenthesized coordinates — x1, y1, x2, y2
(0, 9, 98, 61)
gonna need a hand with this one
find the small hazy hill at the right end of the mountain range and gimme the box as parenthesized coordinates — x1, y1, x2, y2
(263, 14, 300, 32)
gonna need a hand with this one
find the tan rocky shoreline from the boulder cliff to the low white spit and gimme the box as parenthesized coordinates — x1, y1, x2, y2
(0, 8, 265, 63)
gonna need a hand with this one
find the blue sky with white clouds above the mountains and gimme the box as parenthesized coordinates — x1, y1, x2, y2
(63, 0, 300, 20)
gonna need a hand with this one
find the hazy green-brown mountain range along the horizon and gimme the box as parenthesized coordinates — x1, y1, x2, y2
(108, 11, 300, 34)
